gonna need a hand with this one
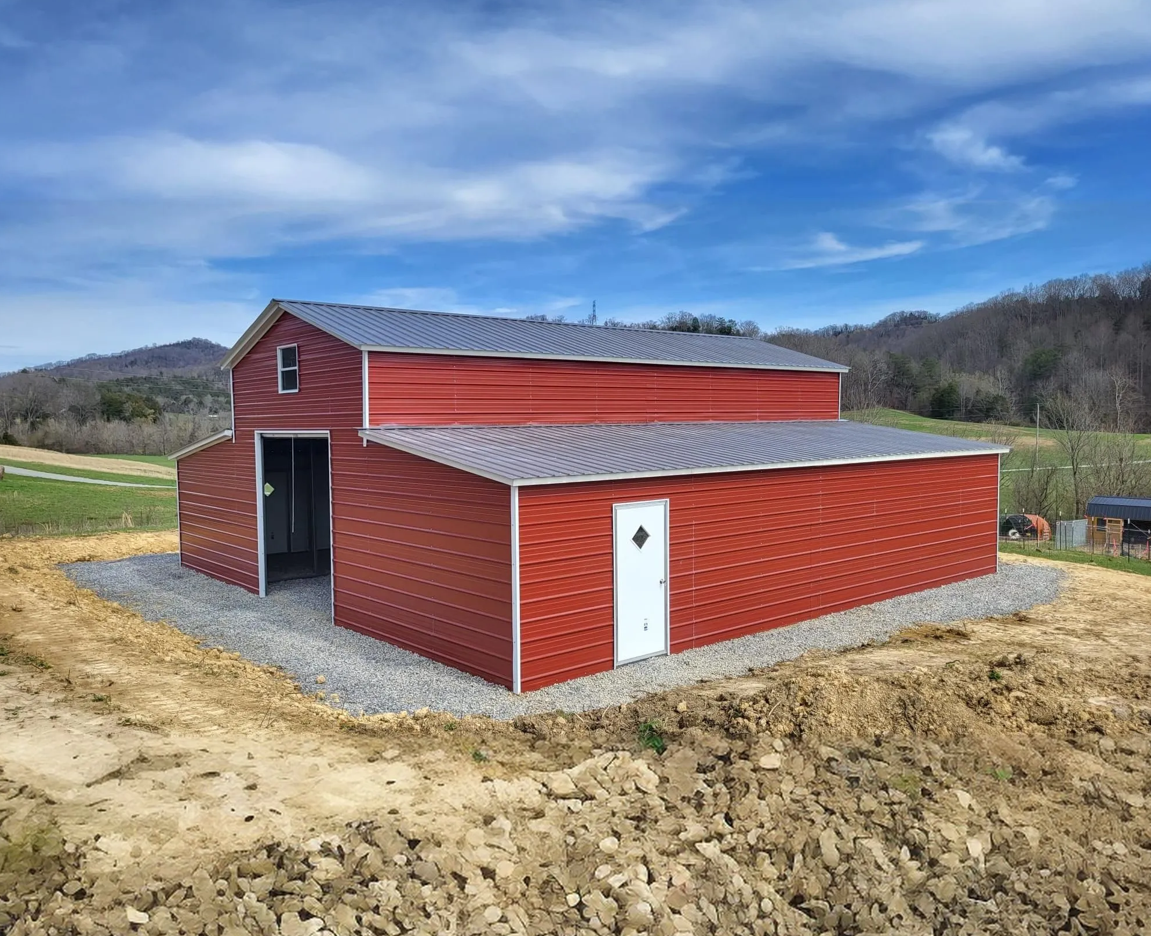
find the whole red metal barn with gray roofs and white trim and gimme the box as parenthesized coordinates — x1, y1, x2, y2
(174, 300, 1006, 692)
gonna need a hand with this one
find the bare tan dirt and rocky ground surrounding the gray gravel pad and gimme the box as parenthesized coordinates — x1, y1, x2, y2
(0, 533, 1151, 936)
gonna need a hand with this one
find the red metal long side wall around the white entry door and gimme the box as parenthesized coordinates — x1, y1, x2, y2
(519, 455, 999, 691)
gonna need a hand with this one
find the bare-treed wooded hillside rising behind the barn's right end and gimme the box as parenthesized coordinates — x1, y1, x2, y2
(767, 264, 1151, 431)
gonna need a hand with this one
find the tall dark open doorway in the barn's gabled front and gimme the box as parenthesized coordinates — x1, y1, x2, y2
(259, 433, 331, 584)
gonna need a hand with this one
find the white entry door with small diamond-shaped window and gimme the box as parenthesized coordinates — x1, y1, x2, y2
(615, 501, 668, 665)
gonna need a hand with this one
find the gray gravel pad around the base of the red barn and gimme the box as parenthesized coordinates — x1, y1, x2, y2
(63, 553, 1064, 718)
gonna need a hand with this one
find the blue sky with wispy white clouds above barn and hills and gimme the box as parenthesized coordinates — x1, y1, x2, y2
(0, 0, 1151, 371)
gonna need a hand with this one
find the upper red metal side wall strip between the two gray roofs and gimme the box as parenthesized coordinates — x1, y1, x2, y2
(368, 351, 839, 426)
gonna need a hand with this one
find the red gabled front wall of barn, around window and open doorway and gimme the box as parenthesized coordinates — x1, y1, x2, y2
(180, 314, 511, 685)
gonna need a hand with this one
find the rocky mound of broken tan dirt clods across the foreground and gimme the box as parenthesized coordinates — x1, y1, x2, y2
(8, 729, 1151, 936)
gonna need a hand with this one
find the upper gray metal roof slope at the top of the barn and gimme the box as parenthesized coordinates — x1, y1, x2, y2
(273, 299, 847, 372)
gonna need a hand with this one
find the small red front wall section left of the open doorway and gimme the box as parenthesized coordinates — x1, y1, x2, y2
(176, 441, 260, 592)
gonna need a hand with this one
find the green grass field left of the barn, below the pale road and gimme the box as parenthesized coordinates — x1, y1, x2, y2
(0, 474, 176, 537)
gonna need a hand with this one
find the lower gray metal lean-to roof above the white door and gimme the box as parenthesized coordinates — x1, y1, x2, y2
(361, 420, 1007, 484)
